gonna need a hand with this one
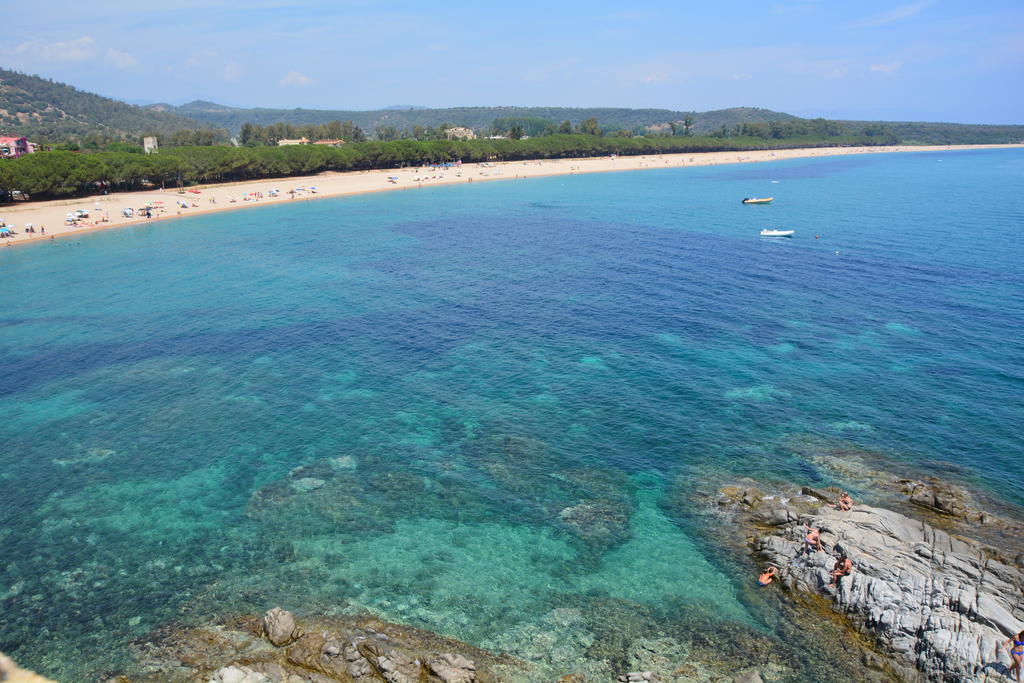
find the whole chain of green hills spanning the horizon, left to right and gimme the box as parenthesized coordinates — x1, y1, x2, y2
(0, 69, 1024, 145)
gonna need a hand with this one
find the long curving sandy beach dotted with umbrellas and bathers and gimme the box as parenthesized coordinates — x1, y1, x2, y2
(0, 144, 1024, 247)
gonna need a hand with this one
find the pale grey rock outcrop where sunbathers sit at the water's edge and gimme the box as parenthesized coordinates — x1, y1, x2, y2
(719, 486, 1024, 681)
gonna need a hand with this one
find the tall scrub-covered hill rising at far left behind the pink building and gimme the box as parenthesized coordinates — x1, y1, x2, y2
(0, 69, 216, 143)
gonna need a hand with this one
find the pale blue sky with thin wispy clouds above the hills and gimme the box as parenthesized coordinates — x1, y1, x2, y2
(0, 0, 1024, 124)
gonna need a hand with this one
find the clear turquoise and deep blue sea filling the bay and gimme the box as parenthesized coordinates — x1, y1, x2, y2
(0, 151, 1024, 680)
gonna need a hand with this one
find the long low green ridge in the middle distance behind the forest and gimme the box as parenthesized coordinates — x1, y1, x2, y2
(153, 102, 798, 134)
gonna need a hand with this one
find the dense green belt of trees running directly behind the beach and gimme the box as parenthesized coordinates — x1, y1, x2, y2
(0, 129, 897, 200)
